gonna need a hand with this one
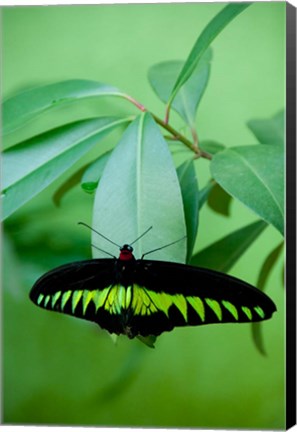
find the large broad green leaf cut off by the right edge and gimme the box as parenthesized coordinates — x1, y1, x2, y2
(210, 145, 284, 234)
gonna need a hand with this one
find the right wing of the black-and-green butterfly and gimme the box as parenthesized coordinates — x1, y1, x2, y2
(125, 260, 276, 336)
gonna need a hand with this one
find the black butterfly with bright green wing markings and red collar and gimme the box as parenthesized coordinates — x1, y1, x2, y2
(30, 224, 276, 338)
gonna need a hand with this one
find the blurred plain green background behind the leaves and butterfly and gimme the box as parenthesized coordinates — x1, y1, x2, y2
(2, 2, 286, 429)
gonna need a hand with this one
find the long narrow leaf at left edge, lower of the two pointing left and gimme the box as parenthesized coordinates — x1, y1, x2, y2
(2, 117, 129, 219)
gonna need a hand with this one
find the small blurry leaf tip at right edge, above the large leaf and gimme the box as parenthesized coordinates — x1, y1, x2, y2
(248, 110, 285, 145)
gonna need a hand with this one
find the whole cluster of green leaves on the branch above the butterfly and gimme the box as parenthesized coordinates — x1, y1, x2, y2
(2, 3, 284, 338)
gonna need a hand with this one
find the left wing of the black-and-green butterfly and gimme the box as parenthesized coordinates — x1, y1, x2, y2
(30, 259, 126, 334)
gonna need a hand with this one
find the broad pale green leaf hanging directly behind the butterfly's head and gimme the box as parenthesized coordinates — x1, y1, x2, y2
(92, 113, 186, 262)
